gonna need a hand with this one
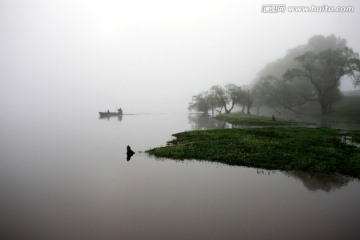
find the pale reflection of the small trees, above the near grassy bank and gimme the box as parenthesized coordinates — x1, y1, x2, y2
(188, 114, 231, 130)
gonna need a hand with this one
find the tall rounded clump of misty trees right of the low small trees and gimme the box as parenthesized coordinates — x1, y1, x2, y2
(254, 35, 360, 115)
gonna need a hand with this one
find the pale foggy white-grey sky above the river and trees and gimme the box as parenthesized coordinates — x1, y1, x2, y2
(0, 0, 360, 114)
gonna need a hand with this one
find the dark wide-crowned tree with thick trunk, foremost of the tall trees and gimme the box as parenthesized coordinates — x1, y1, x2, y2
(284, 47, 360, 115)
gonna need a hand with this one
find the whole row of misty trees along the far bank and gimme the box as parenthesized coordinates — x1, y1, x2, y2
(188, 35, 360, 116)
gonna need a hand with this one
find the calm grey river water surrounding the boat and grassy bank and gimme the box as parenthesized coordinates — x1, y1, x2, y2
(0, 112, 360, 240)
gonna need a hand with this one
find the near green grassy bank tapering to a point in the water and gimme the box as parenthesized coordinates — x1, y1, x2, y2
(147, 126, 360, 177)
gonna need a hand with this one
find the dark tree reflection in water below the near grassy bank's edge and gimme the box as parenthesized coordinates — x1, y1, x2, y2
(257, 170, 354, 192)
